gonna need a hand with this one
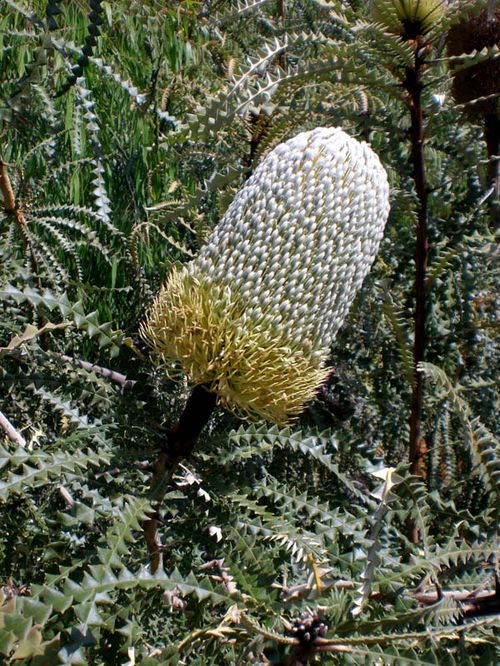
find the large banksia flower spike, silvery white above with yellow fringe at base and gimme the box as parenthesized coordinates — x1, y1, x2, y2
(141, 128, 389, 424)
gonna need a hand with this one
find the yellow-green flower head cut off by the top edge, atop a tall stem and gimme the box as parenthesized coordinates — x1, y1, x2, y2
(373, 0, 446, 39)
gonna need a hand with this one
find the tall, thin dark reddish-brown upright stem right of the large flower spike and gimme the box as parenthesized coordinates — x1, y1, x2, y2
(404, 48, 429, 543)
